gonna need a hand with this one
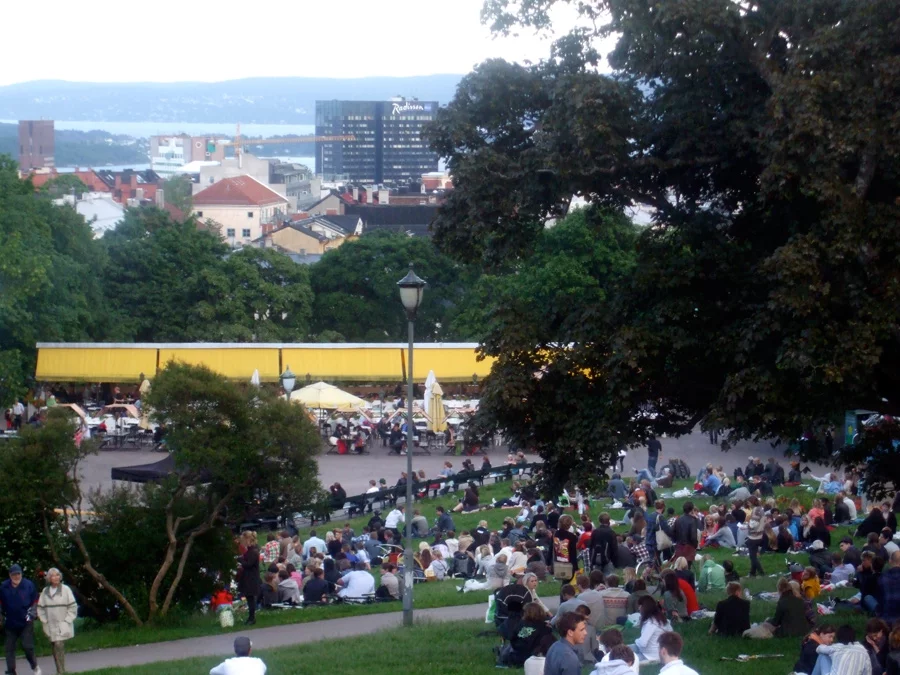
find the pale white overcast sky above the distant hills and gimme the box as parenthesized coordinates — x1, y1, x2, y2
(0, 0, 608, 85)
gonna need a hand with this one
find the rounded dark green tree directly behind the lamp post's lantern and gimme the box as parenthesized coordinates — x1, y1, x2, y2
(310, 232, 474, 342)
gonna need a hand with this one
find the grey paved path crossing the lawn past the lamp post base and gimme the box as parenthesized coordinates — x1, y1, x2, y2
(17, 598, 559, 675)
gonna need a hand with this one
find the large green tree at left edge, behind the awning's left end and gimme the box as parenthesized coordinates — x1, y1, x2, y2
(0, 155, 109, 406)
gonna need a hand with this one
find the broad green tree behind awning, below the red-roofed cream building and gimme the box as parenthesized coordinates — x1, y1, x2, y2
(103, 208, 312, 342)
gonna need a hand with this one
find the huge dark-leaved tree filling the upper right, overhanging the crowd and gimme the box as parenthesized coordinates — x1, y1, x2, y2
(432, 0, 900, 494)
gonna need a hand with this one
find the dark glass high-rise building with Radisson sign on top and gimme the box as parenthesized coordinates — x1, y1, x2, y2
(316, 98, 438, 185)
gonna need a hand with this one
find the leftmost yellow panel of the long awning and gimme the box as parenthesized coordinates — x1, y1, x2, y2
(35, 347, 156, 382)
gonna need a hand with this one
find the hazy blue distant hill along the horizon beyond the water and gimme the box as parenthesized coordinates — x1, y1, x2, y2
(0, 75, 462, 124)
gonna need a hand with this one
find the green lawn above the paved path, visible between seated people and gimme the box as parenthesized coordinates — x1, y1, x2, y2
(44, 482, 848, 672)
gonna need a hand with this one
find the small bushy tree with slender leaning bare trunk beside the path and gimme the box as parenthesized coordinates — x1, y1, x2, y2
(147, 363, 321, 620)
